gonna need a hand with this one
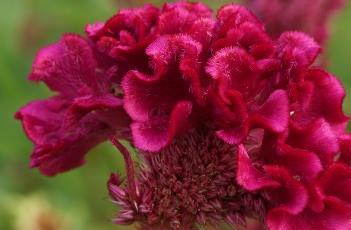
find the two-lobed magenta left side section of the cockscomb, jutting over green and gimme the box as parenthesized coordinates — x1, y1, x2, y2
(16, 34, 129, 176)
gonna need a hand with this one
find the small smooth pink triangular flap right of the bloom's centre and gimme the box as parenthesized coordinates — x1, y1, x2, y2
(250, 90, 289, 133)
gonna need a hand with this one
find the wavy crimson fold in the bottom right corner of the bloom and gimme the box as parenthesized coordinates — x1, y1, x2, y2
(266, 199, 351, 230)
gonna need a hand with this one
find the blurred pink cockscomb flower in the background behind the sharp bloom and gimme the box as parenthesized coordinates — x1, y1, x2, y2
(244, 0, 345, 44)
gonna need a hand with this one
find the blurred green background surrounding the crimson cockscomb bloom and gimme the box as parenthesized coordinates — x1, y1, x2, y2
(0, 0, 351, 230)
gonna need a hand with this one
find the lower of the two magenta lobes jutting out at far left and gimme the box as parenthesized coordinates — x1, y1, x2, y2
(16, 96, 129, 176)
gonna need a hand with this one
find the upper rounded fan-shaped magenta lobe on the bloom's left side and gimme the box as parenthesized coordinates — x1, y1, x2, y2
(29, 34, 98, 97)
